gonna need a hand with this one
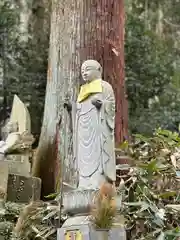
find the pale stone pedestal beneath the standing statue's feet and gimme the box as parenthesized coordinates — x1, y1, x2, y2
(57, 189, 126, 240)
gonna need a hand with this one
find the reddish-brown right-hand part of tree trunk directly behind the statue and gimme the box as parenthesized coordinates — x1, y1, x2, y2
(80, 0, 128, 144)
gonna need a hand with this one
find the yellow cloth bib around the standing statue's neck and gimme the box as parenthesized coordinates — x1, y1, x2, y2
(77, 79, 102, 102)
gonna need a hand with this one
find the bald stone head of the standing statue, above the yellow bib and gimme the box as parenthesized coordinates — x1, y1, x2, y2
(81, 60, 102, 82)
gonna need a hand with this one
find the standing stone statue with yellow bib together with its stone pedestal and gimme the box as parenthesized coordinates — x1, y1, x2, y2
(57, 60, 126, 240)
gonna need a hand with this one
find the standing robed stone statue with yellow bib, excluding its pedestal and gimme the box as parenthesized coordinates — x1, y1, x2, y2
(64, 60, 116, 189)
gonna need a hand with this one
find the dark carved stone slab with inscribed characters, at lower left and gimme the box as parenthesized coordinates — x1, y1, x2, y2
(7, 174, 41, 203)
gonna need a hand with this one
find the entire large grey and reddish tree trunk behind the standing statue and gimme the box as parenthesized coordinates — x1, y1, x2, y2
(33, 0, 127, 198)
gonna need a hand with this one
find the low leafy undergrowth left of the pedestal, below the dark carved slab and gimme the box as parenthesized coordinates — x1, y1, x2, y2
(0, 202, 59, 240)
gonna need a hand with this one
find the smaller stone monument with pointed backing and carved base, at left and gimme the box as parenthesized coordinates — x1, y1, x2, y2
(0, 95, 41, 203)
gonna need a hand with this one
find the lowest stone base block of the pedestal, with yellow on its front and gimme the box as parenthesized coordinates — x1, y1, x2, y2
(57, 216, 126, 240)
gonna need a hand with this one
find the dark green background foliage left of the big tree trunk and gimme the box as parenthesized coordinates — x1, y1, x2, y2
(0, 0, 49, 134)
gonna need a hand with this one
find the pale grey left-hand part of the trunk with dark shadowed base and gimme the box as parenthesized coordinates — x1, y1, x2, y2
(32, 0, 80, 197)
